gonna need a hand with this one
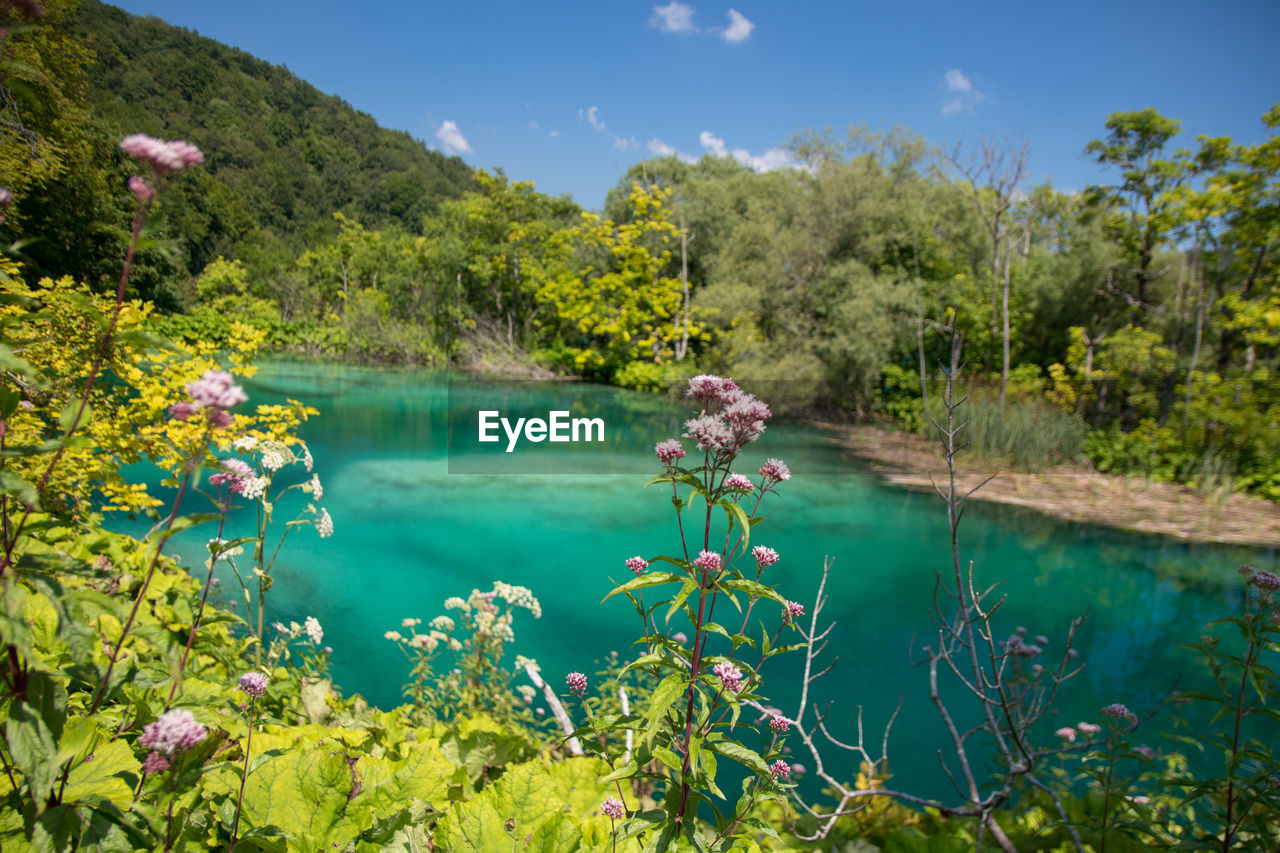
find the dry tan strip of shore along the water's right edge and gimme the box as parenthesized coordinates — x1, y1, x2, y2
(827, 424, 1280, 547)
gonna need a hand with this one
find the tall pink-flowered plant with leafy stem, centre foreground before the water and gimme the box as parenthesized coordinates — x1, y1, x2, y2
(586, 375, 804, 849)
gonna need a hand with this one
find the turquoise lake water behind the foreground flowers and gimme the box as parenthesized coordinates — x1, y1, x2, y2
(127, 362, 1277, 794)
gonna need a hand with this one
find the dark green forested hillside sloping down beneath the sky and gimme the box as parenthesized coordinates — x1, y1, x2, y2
(5, 0, 475, 298)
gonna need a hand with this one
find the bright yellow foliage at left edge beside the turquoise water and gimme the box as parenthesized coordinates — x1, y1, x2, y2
(0, 256, 316, 516)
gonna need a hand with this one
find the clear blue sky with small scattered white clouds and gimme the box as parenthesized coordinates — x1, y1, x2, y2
(104, 0, 1280, 209)
